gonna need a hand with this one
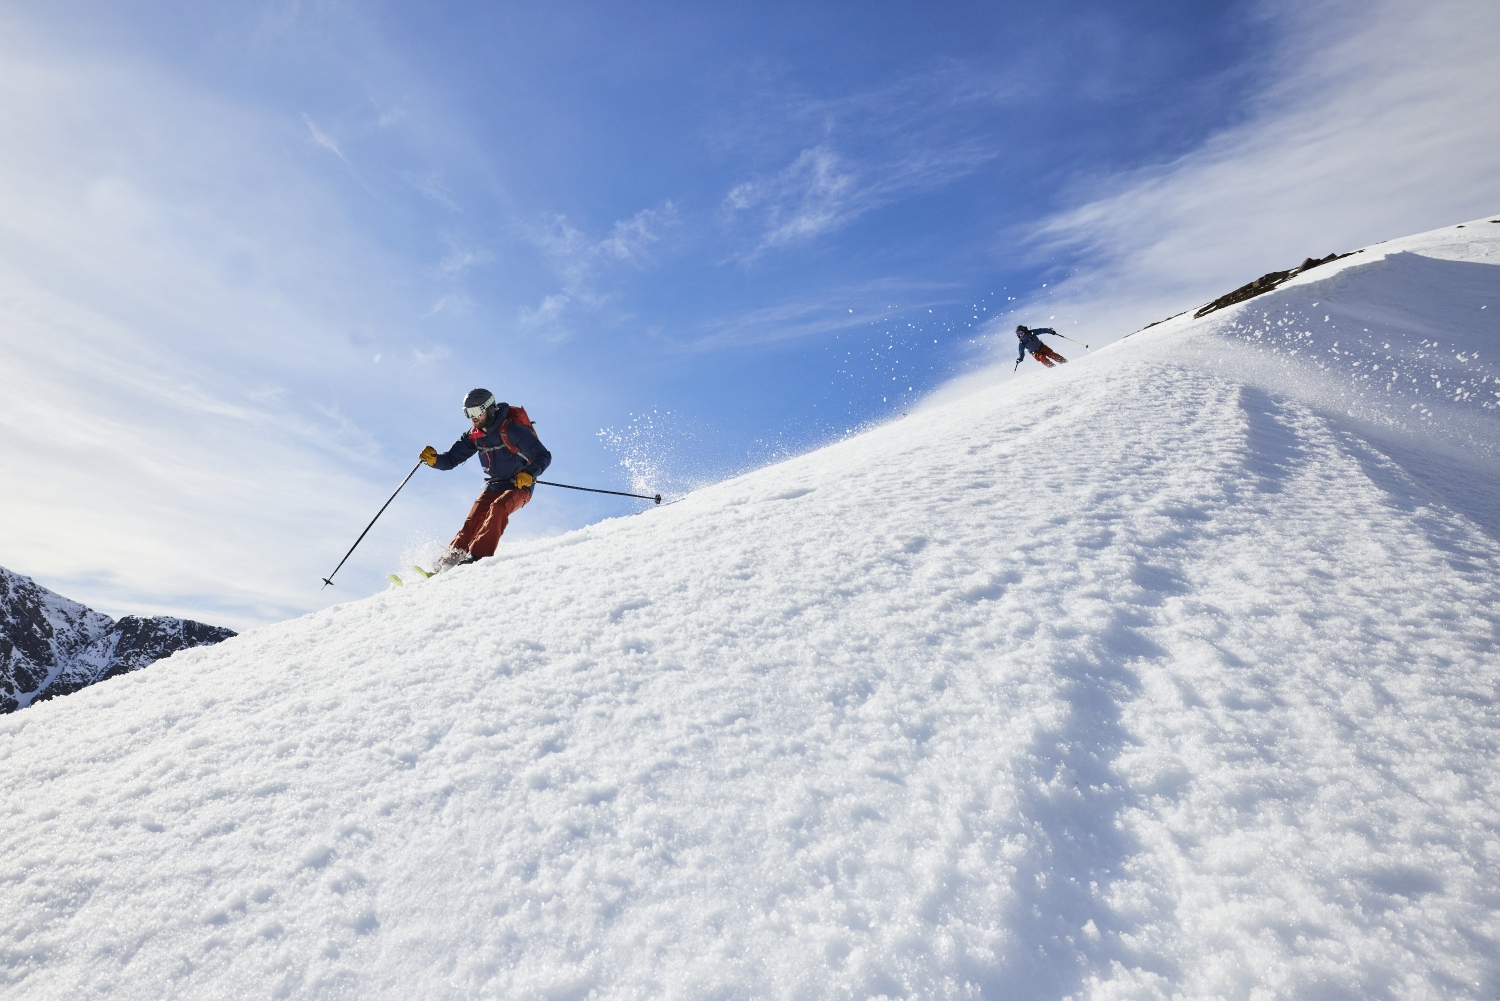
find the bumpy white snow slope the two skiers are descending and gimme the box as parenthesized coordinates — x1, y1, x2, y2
(0, 221, 1500, 999)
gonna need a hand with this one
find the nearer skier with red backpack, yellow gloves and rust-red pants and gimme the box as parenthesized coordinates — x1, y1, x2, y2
(422, 389, 552, 570)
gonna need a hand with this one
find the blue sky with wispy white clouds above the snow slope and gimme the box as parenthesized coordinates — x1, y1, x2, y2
(0, 0, 1500, 627)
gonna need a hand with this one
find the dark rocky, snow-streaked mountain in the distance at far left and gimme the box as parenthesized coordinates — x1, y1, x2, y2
(0, 567, 234, 713)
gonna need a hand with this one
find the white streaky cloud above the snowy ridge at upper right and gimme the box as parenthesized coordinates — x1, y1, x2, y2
(1002, 0, 1500, 347)
